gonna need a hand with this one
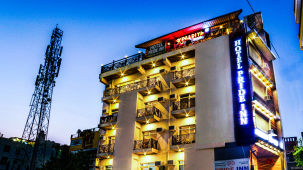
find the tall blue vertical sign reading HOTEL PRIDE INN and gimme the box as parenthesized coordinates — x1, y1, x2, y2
(229, 31, 255, 145)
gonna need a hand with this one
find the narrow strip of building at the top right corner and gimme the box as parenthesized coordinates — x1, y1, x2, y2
(294, 0, 303, 50)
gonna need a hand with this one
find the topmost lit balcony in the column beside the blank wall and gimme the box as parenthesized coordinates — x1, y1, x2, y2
(172, 68, 195, 88)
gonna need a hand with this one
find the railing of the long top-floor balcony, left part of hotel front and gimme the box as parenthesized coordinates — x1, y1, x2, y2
(104, 77, 162, 97)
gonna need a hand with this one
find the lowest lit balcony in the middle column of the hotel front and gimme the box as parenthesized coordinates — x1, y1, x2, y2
(134, 139, 160, 155)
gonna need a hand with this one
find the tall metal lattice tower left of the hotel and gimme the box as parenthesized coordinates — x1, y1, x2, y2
(22, 26, 63, 169)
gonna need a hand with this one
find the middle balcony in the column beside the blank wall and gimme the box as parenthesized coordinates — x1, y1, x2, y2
(171, 98, 195, 118)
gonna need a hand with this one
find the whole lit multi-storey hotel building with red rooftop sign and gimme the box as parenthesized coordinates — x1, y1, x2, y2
(95, 10, 285, 170)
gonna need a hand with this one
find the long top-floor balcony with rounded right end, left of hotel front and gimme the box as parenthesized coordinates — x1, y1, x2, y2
(104, 77, 162, 99)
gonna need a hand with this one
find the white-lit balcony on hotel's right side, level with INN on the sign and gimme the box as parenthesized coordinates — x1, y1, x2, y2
(252, 93, 276, 119)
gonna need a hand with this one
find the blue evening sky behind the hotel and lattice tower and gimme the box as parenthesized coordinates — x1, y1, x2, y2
(0, 0, 303, 144)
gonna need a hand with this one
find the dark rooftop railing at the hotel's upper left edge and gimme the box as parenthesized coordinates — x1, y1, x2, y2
(101, 53, 144, 74)
